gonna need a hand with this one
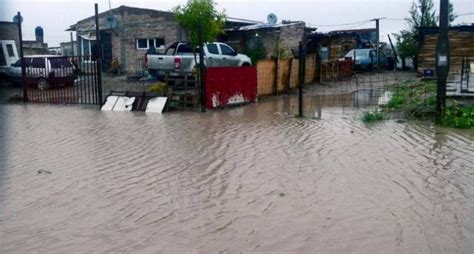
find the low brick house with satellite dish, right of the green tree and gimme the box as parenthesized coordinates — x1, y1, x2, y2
(220, 21, 315, 58)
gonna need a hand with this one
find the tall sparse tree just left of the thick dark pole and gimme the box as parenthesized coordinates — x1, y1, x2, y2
(395, 0, 457, 67)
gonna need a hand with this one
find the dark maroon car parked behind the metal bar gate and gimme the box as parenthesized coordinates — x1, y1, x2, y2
(8, 55, 76, 90)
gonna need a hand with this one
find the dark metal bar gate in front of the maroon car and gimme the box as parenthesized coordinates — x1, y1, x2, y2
(20, 56, 102, 104)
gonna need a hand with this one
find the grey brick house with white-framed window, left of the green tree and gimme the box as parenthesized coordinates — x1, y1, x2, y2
(67, 6, 254, 73)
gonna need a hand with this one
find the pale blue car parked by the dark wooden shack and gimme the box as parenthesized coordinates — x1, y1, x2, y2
(344, 49, 388, 70)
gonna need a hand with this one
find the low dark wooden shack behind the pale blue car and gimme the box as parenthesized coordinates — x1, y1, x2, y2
(308, 28, 377, 61)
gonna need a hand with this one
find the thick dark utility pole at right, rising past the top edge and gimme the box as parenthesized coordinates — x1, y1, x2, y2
(436, 0, 449, 122)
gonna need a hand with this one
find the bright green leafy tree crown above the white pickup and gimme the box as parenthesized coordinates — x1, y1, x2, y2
(173, 0, 225, 49)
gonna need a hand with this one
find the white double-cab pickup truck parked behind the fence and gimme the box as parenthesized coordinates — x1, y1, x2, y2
(145, 42, 252, 79)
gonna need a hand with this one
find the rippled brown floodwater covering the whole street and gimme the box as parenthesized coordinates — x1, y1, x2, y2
(0, 97, 474, 253)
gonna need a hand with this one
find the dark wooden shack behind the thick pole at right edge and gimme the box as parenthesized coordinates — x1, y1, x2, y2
(417, 25, 474, 73)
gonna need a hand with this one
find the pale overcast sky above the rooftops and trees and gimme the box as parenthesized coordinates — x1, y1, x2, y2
(0, 0, 474, 47)
